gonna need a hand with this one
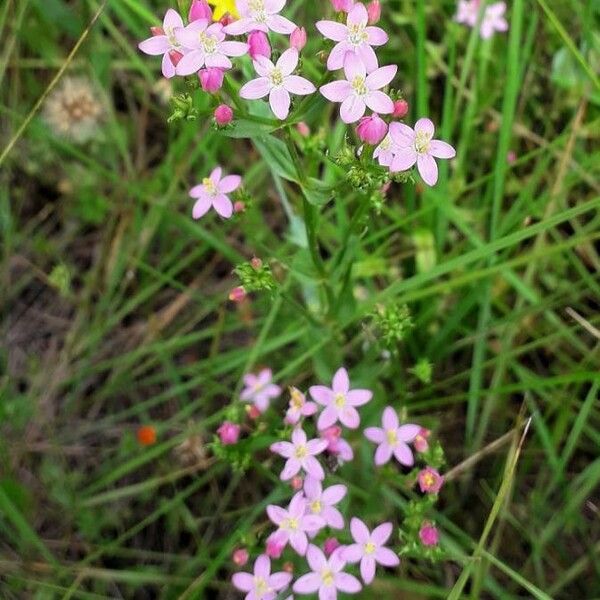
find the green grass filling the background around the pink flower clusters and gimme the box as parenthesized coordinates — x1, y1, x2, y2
(0, 0, 600, 600)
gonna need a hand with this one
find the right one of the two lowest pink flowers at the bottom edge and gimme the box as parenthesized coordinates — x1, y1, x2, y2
(293, 544, 362, 600)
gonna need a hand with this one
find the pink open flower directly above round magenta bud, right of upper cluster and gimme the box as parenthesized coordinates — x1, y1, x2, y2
(319, 52, 398, 123)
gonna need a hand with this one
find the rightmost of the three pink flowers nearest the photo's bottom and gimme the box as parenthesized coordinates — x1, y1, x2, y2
(342, 517, 400, 585)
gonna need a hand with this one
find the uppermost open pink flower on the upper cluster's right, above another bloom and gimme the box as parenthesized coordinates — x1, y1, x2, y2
(316, 2, 395, 72)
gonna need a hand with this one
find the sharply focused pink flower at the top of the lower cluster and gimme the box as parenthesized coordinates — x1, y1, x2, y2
(309, 367, 373, 429)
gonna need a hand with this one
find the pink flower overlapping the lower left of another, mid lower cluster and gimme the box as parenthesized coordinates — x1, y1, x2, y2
(267, 492, 325, 556)
